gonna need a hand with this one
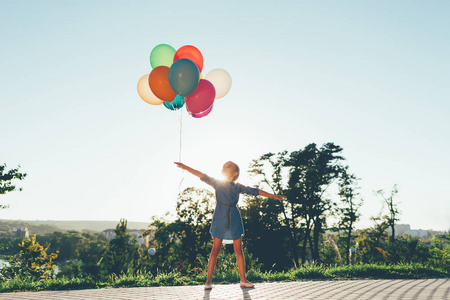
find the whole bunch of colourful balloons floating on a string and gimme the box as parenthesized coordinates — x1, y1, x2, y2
(137, 44, 231, 118)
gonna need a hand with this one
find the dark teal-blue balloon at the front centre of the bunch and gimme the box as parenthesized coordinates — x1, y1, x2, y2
(169, 58, 200, 97)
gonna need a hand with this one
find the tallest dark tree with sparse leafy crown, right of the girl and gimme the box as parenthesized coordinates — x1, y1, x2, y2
(249, 143, 344, 264)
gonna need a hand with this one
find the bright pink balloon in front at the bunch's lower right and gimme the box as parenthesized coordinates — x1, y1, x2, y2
(186, 79, 216, 114)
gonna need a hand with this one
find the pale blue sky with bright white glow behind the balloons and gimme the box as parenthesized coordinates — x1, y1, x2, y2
(0, 0, 450, 230)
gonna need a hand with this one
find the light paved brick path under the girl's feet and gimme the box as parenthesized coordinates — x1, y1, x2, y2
(0, 278, 450, 300)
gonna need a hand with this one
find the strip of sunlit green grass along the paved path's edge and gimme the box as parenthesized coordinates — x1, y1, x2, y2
(0, 264, 450, 292)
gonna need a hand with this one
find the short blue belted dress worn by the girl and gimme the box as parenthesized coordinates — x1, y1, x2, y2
(201, 175, 259, 240)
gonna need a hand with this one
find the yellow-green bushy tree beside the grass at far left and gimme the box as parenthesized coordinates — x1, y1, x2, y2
(1, 235, 59, 279)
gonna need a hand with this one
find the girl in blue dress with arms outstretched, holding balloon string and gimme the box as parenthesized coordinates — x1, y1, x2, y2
(175, 161, 286, 290)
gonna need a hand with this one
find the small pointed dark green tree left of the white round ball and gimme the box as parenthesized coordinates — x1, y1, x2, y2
(105, 219, 141, 275)
